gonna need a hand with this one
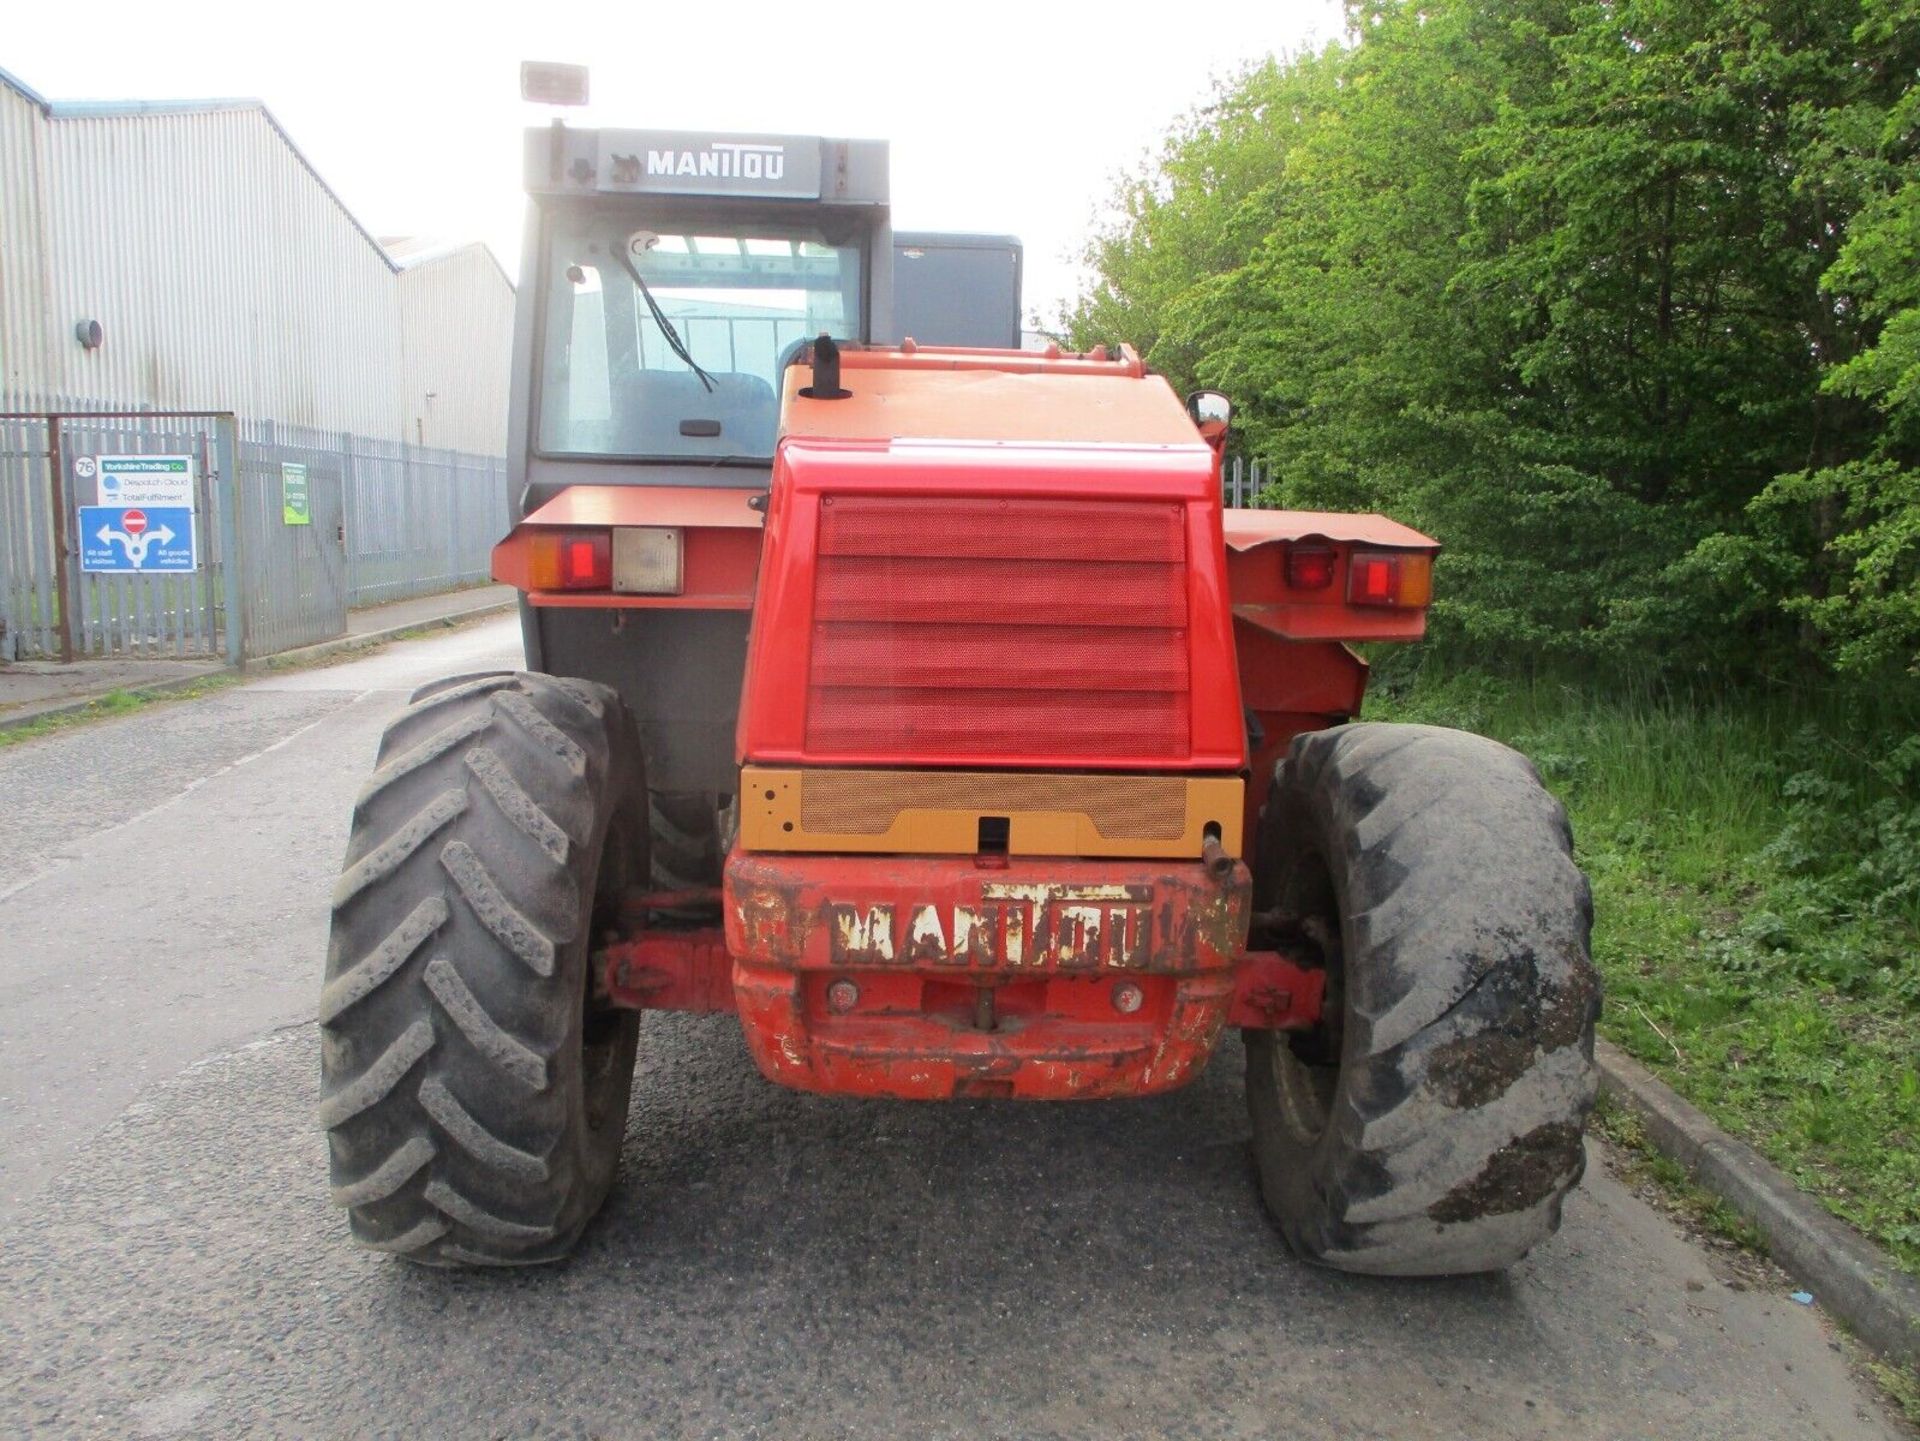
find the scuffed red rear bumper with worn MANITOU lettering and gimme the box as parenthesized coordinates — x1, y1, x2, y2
(724, 850, 1250, 1099)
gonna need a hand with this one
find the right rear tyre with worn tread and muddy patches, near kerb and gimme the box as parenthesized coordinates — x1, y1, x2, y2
(1246, 725, 1599, 1276)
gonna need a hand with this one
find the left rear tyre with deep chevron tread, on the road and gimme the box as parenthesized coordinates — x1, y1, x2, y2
(319, 672, 647, 1264)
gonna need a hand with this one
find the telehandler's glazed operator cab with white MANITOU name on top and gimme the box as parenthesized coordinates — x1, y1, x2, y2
(513, 127, 893, 508)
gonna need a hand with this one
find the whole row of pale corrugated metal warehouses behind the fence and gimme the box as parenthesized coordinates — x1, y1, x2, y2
(0, 71, 513, 455)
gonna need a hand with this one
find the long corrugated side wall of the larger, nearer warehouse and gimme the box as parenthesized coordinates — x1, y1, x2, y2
(25, 107, 403, 439)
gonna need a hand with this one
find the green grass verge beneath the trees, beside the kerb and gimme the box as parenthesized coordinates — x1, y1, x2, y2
(1367, 656, 1920, 1274)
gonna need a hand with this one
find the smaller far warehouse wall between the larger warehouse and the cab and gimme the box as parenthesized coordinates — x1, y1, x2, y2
(399, 244, 513, 455)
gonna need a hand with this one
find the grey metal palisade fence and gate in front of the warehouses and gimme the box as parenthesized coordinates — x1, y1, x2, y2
(0, 411, 507, 664)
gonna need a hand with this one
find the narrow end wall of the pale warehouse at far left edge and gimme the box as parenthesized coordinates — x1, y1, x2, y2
(0, 81, 52, 411)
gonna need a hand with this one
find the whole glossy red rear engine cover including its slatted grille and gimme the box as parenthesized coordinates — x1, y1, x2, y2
(739, 439, 1246, 769)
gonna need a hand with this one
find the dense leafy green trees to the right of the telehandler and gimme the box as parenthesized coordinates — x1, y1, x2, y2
(1068, 0, 1920, 668)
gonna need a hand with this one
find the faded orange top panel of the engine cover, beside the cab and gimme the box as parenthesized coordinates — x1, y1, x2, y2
(780, 342, 1206, 449)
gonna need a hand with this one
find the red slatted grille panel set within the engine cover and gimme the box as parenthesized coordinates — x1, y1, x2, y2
(806, 495, 1190, 760)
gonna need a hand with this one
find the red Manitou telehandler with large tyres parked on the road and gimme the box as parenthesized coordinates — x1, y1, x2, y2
(319, 125, 1599, 1274)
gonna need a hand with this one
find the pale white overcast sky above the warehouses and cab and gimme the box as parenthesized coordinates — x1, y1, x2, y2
(0, 0, 1340, 319)
